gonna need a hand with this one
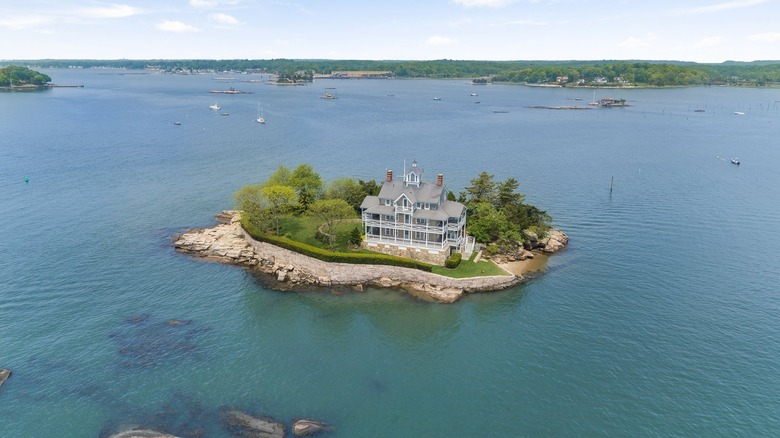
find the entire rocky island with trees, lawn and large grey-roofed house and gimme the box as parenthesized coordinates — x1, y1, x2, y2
(174, 162, 568, 303)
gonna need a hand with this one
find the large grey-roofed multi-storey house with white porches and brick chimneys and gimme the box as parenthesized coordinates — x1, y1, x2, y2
(360, 162, 466, 264)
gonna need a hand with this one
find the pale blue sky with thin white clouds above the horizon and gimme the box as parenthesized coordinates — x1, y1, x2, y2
(0, 0, 780, 63)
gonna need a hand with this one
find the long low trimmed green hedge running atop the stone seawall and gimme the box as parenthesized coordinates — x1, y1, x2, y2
(241, 217, 433, 272)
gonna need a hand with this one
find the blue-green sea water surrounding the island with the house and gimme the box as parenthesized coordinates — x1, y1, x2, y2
(0, 70, 780, 437)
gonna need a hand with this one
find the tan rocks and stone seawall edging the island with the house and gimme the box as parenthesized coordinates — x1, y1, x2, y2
(173, 210, 568, 303)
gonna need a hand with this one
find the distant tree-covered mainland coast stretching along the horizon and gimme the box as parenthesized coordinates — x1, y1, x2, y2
(6, 59, 780, 88)
